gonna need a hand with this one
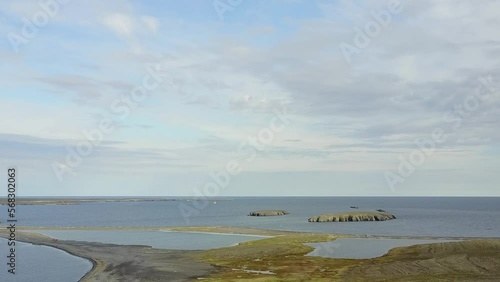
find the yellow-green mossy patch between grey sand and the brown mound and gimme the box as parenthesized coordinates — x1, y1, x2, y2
(197, 234, 349, 281)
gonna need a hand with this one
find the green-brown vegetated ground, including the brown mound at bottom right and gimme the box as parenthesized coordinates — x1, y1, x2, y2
(196, 234, 500, 281)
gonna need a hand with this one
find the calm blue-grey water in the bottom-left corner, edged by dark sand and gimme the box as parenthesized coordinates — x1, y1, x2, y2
(0, 238, 92, 282)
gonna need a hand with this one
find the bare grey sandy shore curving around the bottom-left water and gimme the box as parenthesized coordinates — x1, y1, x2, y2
(0, 230, 217, 281)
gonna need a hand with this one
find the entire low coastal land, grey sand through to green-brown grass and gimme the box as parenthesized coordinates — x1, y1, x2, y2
(0, 226, 500, 282)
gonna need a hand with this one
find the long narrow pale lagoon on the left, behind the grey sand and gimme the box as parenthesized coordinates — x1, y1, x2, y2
(32, 230, 267, 250)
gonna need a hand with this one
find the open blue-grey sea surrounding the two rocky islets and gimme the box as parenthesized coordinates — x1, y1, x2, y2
(13, 197, 500, 237)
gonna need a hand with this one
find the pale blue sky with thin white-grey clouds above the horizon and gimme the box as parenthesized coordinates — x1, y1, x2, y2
(0, 0, 500, 197)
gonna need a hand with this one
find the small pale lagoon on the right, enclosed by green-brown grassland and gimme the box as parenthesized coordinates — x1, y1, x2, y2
(306, 238, 456, 259)
